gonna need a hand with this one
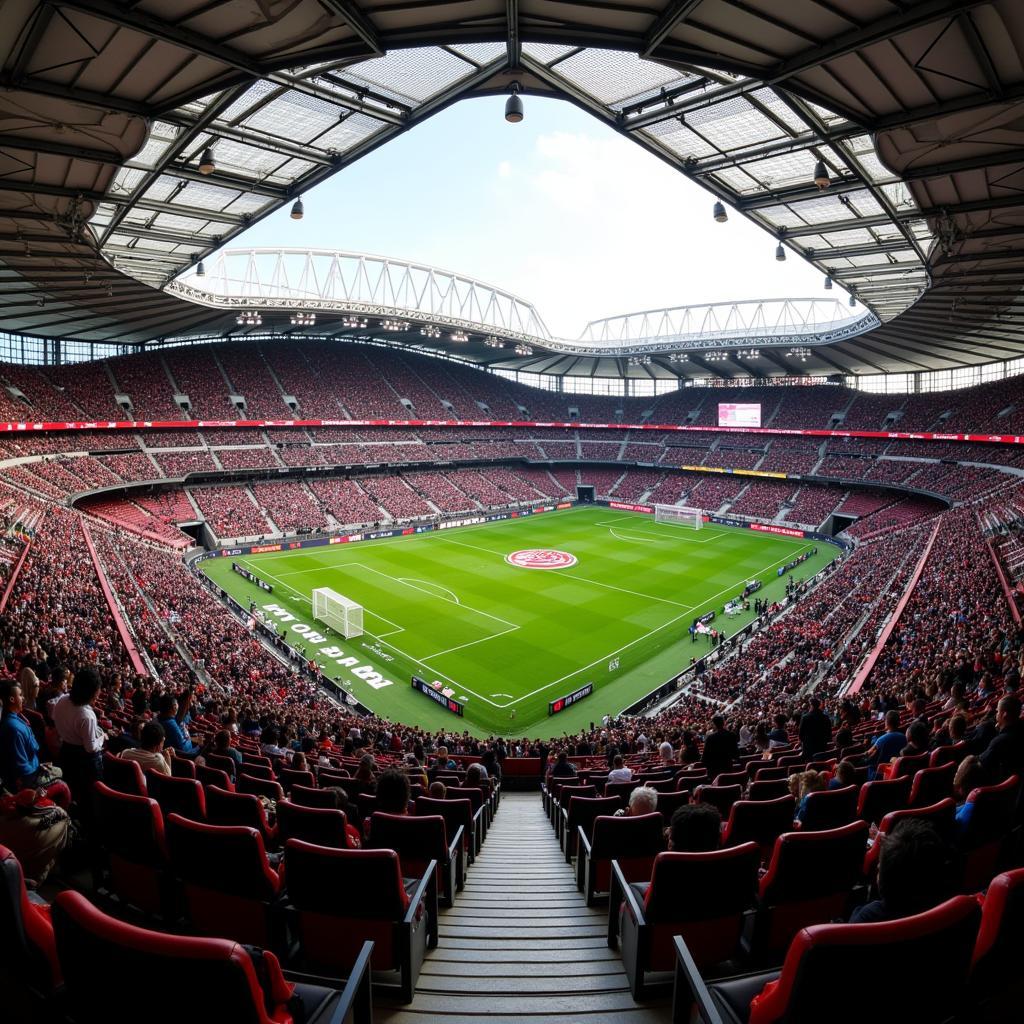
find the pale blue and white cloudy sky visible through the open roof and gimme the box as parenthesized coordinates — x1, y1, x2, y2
(231, 96, 845, 338)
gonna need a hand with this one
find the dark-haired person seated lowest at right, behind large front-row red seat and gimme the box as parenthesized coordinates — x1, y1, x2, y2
(850, 818, 951, 925)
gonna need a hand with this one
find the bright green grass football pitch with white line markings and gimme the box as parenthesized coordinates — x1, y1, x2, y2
(195, 506, 838, 736)
